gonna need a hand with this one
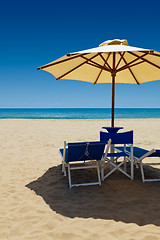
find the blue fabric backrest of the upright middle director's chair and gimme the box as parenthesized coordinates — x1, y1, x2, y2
(100, 131, 133, 144)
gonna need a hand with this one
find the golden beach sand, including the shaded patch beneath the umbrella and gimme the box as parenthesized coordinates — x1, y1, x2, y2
(0, 119, 160, 240)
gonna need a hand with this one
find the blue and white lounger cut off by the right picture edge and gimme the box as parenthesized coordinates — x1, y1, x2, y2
(116, 147, 160, 182)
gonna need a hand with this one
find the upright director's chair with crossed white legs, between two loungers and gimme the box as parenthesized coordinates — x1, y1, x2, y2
(100, 131, 134, 181)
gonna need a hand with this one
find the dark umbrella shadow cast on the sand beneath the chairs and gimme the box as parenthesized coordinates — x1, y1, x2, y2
(26, 165, 160, 226)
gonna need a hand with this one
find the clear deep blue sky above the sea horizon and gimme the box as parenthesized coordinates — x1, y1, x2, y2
(0, 0, 160, 108)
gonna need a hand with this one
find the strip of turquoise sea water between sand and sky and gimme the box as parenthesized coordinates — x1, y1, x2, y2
(0, 108, 160, 119)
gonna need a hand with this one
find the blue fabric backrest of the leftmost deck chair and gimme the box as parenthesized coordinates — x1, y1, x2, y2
(67, 142, 105, 162)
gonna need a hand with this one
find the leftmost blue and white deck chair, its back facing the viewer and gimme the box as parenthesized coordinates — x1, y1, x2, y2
(59, 142, 105, 188)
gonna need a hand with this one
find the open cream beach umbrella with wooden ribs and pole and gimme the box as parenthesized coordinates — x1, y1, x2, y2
(37, 39, 160, 127)
